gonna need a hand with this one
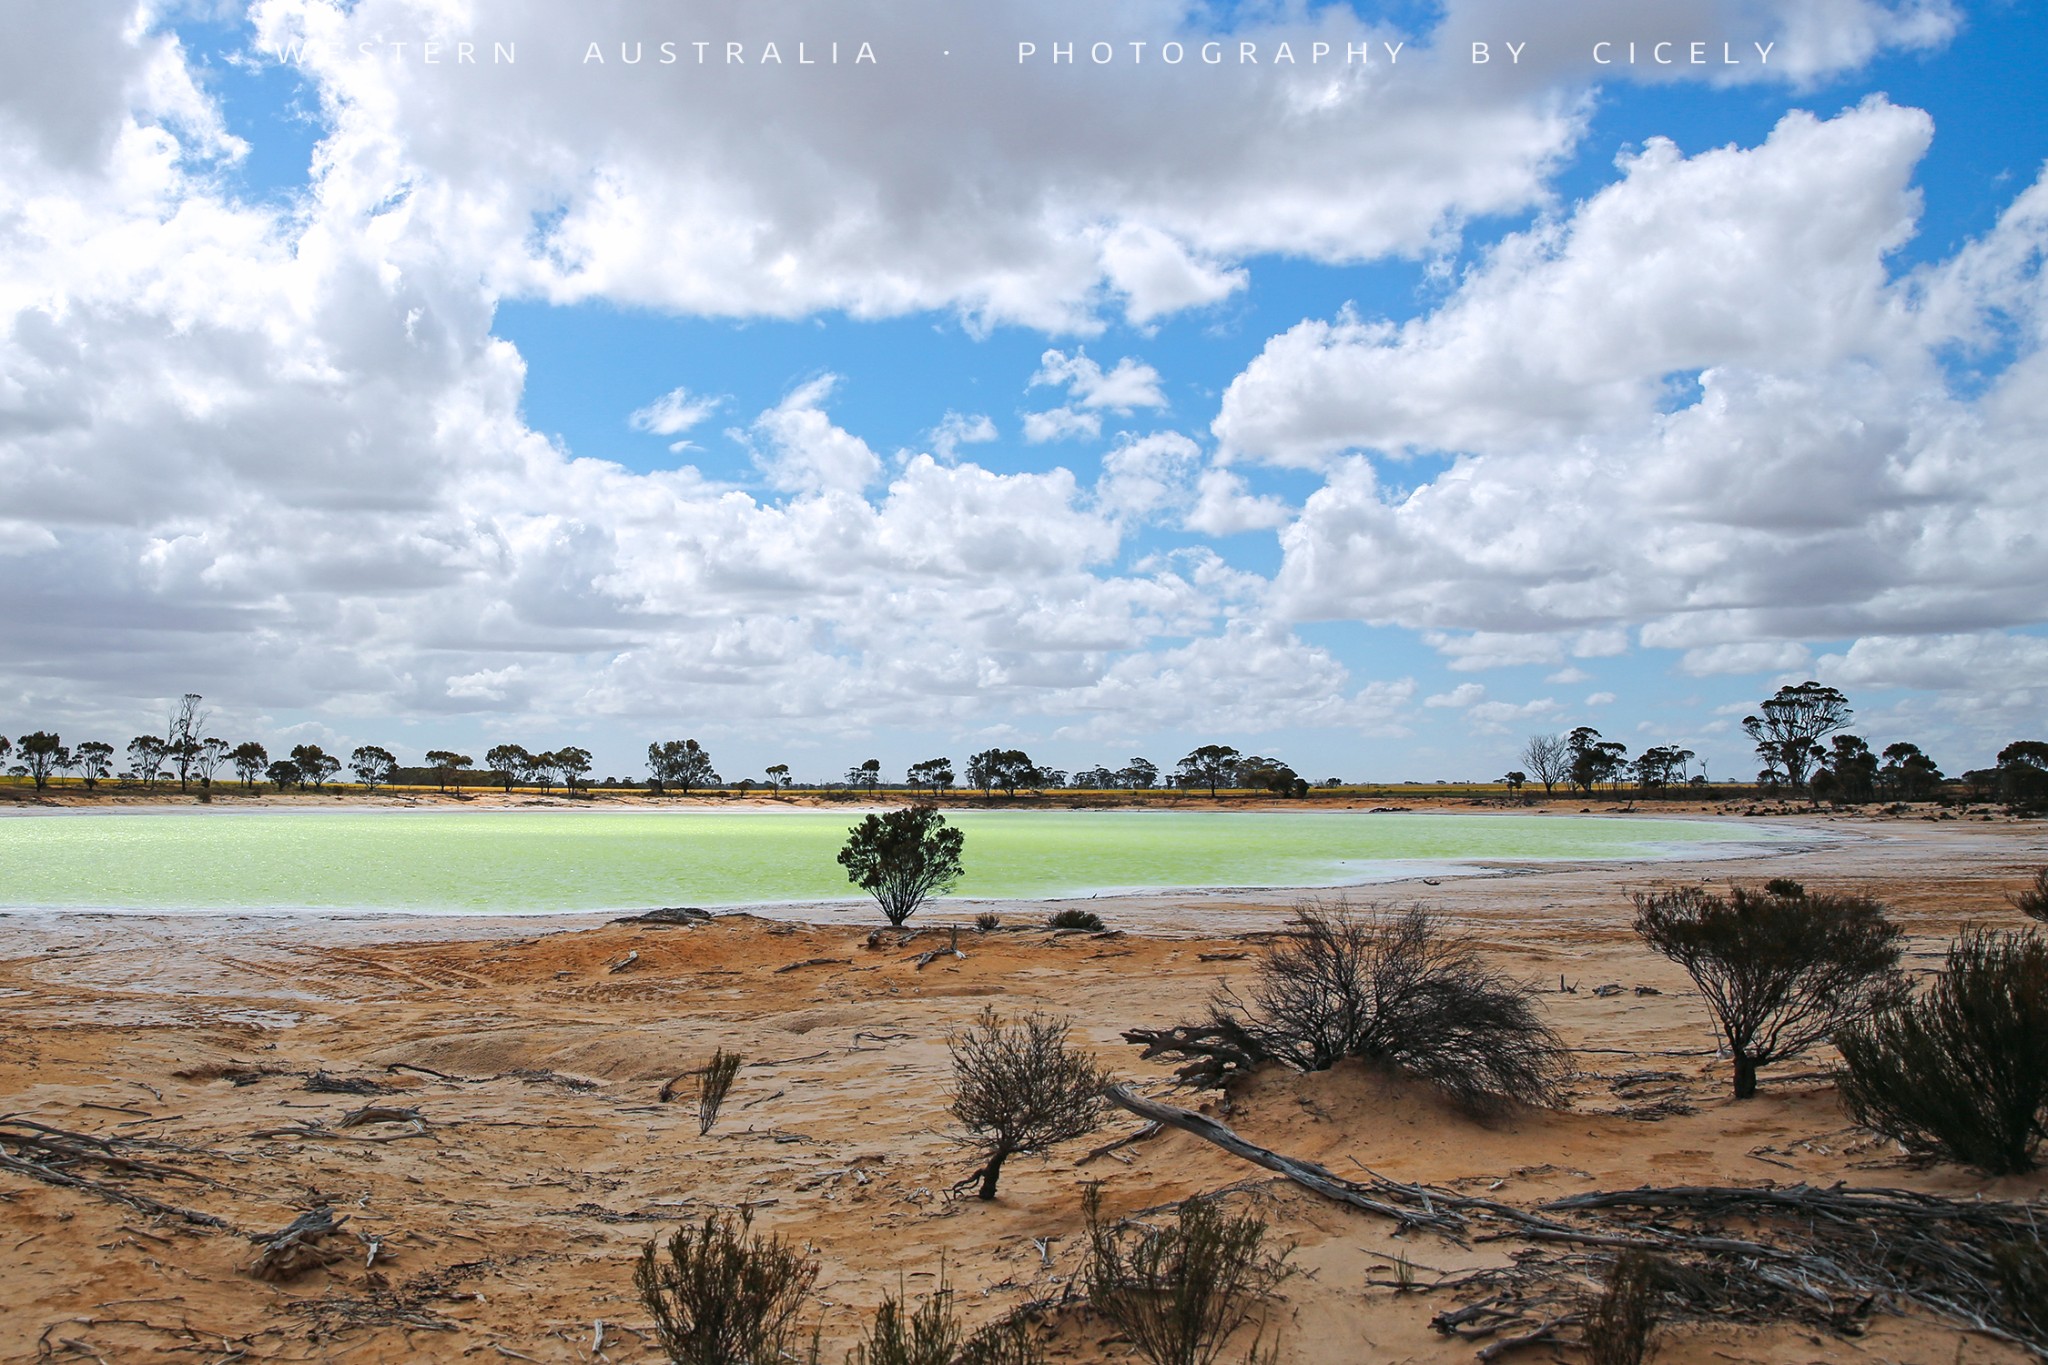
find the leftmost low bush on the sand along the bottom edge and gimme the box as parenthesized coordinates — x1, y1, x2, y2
(633, 1209, 817, 1365)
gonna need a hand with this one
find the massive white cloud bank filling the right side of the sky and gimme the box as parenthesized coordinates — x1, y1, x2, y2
(1253, 102, 2048, 695)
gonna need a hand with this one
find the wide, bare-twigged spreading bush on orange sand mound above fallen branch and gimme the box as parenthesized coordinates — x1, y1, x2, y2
(1124, 902, 1571, 1111)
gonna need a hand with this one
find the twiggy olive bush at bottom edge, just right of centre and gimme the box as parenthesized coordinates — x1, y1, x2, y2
(1081, 1185, 1292, 1365)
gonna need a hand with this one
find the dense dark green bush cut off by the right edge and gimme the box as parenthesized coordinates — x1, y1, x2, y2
(1835, 931, 2048, 1175)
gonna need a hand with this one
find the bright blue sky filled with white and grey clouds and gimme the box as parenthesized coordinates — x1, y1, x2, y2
(0, 0, 2048, 780)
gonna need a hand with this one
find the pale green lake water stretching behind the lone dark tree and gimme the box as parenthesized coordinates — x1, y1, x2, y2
(0, 810, 1767, 911)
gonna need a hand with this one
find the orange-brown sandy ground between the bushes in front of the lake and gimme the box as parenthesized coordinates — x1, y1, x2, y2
(0, 817, 2048, 1365)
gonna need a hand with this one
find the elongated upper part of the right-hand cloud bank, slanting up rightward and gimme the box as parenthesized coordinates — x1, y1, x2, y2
(1214, 100, 1933, 465)
